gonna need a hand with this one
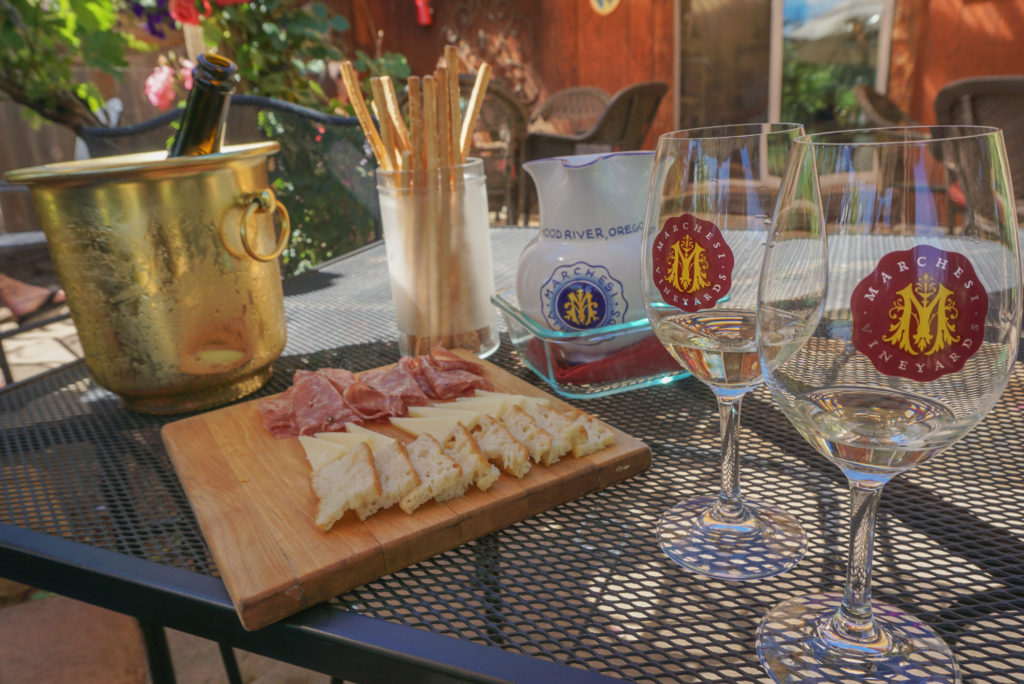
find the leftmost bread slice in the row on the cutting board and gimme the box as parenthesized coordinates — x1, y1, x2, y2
(312, 443, 381, 531)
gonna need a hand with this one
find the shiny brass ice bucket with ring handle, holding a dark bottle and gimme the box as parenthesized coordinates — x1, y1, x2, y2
(5, 142, 288, 414)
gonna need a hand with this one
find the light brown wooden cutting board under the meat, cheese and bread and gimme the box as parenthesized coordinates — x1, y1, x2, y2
(163, 358, 650, 630)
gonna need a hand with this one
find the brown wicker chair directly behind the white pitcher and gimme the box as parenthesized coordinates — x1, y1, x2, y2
(519, 81, 669, 220)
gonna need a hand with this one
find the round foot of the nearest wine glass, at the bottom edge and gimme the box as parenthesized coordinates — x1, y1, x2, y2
(757, 594, 961, 684)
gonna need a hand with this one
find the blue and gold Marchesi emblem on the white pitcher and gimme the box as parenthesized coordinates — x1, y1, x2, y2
(541, 261, 629, 331)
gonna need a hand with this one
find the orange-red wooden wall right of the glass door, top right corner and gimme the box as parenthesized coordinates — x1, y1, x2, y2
(892, 0, 1024, 123)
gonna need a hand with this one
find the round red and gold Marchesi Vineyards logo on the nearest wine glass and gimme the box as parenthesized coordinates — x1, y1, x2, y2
(850, 245, 988, 382)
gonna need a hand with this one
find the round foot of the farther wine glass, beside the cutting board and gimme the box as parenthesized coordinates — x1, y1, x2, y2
(657, 497, 807, 580)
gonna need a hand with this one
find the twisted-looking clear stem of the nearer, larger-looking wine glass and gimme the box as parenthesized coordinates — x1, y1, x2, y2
(822, 481, 886, 644)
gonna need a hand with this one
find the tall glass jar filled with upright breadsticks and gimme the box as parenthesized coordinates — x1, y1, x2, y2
(342, 45, 494, 354)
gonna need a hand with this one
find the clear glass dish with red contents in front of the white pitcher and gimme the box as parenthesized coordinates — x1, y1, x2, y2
(490, 288, 689, 399)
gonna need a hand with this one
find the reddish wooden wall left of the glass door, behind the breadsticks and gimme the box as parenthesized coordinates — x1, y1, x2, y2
(331, 0, 676, 147)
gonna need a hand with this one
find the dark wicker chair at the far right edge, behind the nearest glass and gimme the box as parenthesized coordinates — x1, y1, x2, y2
(935, 76, 1024, 220)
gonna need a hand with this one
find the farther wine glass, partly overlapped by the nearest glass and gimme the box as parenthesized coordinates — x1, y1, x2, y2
(642, 124, 806, 580)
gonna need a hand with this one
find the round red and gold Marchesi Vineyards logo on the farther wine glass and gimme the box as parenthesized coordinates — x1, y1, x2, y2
(651, 214, 733, 312)
